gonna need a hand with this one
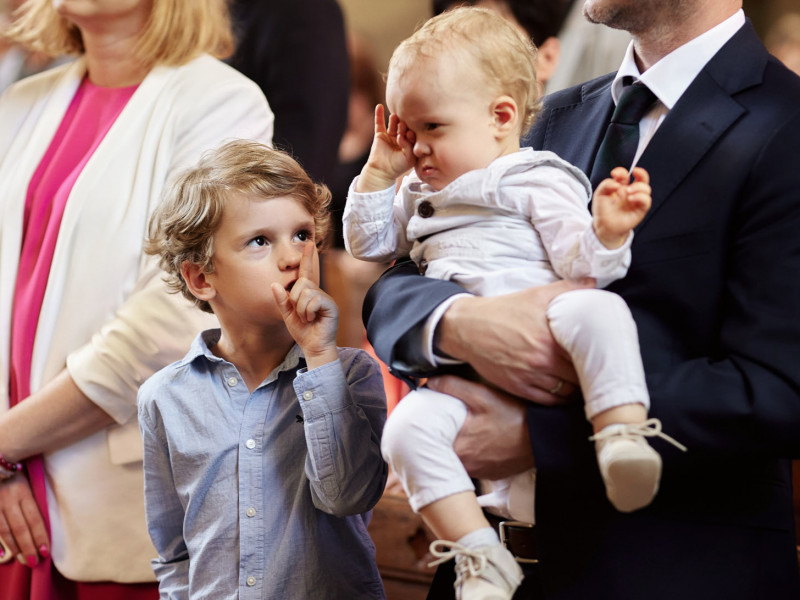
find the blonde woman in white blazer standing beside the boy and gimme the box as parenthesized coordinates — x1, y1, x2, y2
(0, 0, 273, 600)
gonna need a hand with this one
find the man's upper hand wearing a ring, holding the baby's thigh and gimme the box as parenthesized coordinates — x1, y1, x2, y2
(435, 280, 594, 404)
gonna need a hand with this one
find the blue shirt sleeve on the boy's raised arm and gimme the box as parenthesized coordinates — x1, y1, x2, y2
(294, 348, 387, 516)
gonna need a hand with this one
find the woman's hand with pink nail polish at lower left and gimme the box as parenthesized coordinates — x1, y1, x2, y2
(0, 473, 50, 567)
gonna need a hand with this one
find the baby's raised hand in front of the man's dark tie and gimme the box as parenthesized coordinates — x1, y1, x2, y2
(592, 167, 652, 250)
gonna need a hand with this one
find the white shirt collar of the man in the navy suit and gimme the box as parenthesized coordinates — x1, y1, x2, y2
(611, 9, 745, 110)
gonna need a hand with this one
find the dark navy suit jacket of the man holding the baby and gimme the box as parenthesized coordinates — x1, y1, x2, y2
(365, 23, 800, 600)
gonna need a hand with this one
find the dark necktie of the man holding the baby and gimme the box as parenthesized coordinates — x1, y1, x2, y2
(590, 77, 656, 188)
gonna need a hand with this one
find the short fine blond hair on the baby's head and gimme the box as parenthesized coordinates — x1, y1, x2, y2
(389, 6, 540, 135)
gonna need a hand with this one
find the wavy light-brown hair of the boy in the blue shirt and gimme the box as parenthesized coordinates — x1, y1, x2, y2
(144, 140, 331, 312)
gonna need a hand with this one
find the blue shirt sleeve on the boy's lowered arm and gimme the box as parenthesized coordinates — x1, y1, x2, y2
(139, 386, 189, 600)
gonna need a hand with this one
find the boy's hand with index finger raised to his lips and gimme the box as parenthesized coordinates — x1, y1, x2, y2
(271, 242, 339, 369)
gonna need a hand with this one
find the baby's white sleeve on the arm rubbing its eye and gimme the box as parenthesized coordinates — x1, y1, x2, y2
(342, 178, 412, 262)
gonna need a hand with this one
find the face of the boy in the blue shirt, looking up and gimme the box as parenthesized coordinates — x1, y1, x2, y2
(206, 194, 319, 327)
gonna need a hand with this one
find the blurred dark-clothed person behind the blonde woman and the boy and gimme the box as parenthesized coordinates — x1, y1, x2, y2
(228, 0, 349, 184)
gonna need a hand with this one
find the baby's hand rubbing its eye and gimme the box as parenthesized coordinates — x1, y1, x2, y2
(356, 104, 417, 193)
